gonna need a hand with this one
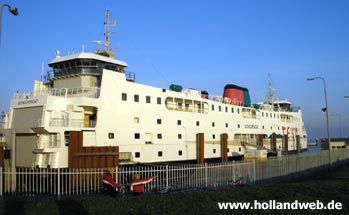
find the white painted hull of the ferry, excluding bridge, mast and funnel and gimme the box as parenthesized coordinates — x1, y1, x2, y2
(3, 67, 307, 168)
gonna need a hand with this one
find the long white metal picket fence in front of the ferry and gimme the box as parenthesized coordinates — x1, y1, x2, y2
(0, 148, 349, 196)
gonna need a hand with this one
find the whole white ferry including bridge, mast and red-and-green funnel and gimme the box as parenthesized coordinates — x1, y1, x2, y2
(3, 11, 307, 168)
